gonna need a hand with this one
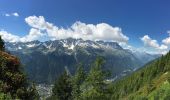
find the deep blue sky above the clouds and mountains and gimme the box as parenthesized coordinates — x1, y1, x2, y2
(0, 0, 170, 54)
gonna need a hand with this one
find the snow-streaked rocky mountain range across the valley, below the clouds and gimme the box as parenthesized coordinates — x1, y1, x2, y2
(5, 38, 160, 83)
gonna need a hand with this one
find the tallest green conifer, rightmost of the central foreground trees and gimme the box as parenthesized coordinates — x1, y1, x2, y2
(81, 57, 108, 100)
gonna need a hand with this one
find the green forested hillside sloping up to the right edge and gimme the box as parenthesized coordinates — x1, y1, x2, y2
(110, 52, 170, 100)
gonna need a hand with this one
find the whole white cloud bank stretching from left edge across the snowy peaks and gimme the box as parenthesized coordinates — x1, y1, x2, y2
(0, 16, 129, 43)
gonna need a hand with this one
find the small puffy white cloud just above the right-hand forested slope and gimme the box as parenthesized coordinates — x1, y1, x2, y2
(141, 35, 168, 50)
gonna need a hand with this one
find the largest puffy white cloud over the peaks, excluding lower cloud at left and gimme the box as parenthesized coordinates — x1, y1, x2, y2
(25, 16, 129, 43)
